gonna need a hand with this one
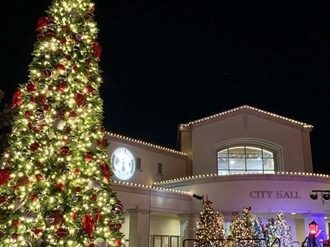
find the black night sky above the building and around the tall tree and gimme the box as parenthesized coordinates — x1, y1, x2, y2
(0, 0, 330, 174)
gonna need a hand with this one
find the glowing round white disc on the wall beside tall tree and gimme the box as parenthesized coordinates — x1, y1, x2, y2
(111, 147, 135, 180)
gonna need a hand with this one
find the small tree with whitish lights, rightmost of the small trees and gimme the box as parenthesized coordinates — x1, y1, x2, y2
(275, 212, 293, 247)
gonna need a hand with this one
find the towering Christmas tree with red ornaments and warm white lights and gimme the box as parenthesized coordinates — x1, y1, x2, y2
(0, 0, 124, 247)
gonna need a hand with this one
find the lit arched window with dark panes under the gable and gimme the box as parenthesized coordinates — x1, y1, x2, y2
(217, 145, 275, 175)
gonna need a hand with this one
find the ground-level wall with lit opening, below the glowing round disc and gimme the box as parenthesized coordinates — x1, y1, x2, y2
(112, 184, 192, 247)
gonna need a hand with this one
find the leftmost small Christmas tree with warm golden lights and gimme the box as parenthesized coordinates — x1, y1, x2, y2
(196, 198, 225, 247)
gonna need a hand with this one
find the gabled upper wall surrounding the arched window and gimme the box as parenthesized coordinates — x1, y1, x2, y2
(192, 113, 305, 175)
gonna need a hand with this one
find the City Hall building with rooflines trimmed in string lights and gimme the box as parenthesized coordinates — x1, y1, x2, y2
(107, 105, 330, 247)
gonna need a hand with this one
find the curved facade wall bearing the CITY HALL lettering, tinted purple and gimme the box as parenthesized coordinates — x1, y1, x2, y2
(166, 175, 330, 214)
